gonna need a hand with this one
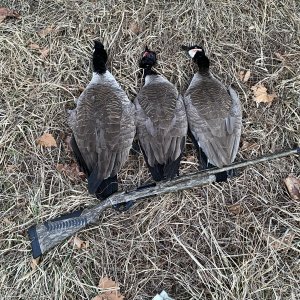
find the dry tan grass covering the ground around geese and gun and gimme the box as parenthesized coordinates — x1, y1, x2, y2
(0, 0, 300, 300)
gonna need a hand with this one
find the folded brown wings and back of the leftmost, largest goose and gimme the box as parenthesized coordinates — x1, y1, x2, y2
(74, 89, 134, 193)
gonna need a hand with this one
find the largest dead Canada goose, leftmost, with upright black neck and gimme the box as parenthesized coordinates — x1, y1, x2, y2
(68, 41, 135, 199)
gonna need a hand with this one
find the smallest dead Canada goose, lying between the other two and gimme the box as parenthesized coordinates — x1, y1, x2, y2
(134, 47, 187, 181)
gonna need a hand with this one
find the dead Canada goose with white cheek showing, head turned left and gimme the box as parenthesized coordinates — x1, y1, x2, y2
(183, 46, 242, 181)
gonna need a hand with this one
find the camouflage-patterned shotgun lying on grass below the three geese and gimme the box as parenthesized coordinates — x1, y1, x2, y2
(28, 148, 300, 258)
